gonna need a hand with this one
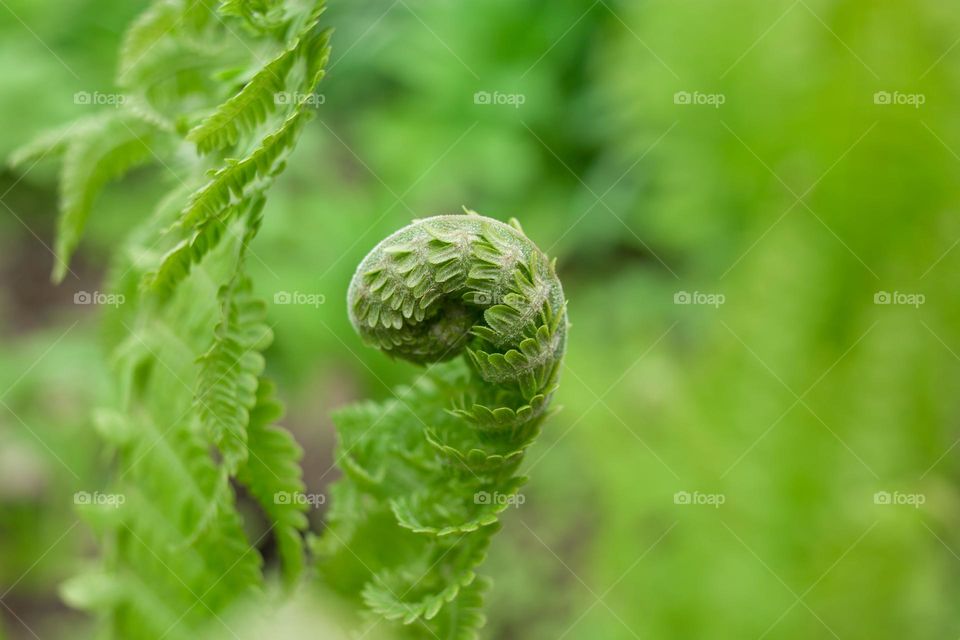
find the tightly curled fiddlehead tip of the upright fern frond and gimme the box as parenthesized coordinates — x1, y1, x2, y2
(348, 212, 566, 368)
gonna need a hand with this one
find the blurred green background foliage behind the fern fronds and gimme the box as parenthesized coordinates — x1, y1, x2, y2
(0, 0, 960, 640)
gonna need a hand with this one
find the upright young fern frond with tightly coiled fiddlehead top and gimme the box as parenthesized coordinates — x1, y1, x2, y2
(317, 212, 567, 639)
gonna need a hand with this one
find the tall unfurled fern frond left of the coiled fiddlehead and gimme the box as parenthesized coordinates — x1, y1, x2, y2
(13, 0, 329, 640)
